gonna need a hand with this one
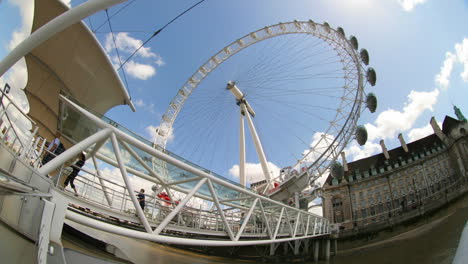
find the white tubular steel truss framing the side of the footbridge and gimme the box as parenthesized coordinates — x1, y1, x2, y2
(39, 97, 329, 246)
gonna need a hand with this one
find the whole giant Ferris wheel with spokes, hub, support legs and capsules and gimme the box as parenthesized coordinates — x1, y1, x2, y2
(155, 20, 377, 190)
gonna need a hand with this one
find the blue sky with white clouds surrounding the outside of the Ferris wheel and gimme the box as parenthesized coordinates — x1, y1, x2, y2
(0, 0, 468, 186)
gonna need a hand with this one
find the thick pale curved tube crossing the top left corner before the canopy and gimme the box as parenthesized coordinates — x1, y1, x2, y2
(0, 0, 125, 76)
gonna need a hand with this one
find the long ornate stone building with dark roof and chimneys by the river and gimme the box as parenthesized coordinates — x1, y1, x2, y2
(323, 116, 468, 237)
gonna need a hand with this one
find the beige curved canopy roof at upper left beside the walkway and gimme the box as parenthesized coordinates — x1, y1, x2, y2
(24, 0, 133, 144)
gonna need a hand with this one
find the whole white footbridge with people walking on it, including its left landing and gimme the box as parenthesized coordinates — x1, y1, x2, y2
(0, 96, 336, 263)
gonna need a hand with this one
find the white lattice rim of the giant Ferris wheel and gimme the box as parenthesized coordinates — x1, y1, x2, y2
(154, 20, 370, 180)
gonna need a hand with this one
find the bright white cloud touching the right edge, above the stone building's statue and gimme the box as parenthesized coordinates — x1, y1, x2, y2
(435, 38, 468, 89)
